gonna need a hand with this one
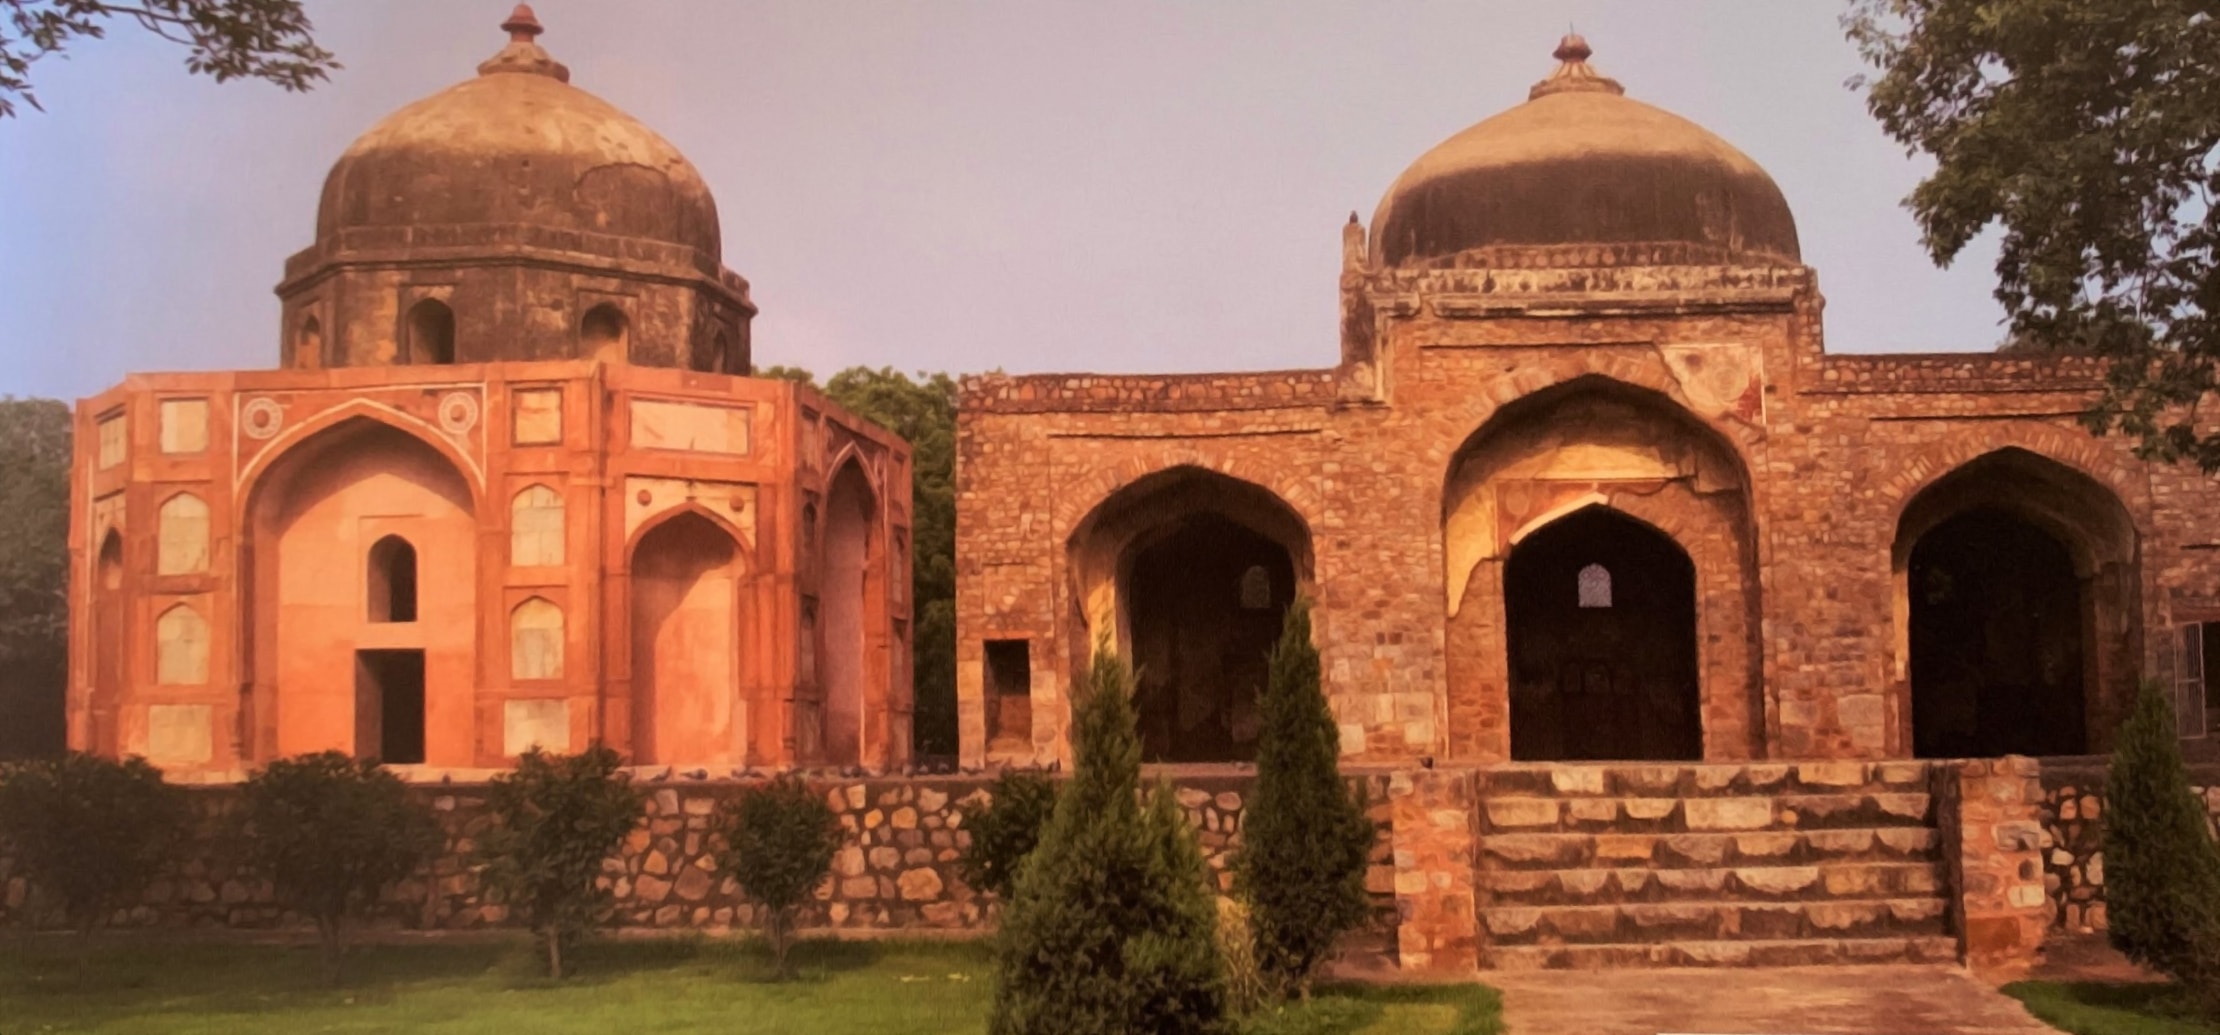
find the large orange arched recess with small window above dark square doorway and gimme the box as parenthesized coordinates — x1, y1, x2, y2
(242, 418, 480, 766)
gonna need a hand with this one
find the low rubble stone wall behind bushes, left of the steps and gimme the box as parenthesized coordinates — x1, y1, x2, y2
(0, 773, 1394, 957)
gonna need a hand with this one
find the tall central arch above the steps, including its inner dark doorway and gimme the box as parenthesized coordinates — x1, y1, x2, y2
(1443, 375, 1767, 762)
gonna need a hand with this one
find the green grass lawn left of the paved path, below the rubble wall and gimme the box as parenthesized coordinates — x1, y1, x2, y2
(0, 935, 1499, 1035)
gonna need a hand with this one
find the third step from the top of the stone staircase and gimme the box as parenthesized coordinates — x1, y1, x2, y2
(1479, 826, 1938, 871)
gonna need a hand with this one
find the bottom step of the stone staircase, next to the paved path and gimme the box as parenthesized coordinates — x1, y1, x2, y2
(1483, 935, 1958, 971)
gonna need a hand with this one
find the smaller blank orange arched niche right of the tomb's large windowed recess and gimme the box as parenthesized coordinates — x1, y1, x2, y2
(633, 513, 744, 764)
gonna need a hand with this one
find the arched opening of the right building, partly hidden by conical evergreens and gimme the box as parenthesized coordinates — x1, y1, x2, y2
(1065, 466, 1310, 762)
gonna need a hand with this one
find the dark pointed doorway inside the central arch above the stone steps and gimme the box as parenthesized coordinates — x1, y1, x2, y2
(1503, 506, 1703, 762)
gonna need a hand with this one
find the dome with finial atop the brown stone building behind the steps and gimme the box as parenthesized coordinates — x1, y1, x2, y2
(1372, 36, 1798, 267)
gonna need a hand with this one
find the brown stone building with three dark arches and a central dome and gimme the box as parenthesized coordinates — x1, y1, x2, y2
(957, 36, 2220, 766)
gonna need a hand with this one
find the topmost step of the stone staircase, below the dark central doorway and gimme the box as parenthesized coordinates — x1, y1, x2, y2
(1479, 762, 1931, 802)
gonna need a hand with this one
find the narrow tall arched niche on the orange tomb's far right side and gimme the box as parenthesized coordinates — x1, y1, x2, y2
(817, 462, 879, 766)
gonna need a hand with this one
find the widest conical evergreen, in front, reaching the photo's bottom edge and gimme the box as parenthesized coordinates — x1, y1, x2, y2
(988, 646, 1228, 1035)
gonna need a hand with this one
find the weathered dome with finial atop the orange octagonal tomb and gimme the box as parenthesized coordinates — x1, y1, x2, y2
(315, 4, 722, 262)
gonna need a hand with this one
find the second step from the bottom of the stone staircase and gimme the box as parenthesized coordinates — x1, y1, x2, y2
(1481, 895, 1949, 946)
